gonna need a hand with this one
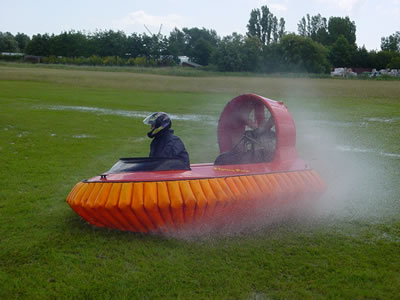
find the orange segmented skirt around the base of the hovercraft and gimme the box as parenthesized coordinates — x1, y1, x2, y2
(67, 170, 325, 232)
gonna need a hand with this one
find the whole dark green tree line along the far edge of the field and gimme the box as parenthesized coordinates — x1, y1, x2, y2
(0, 5, 400, 73)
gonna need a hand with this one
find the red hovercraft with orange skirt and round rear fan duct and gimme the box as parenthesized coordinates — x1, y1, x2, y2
(67, 94, 326, 232)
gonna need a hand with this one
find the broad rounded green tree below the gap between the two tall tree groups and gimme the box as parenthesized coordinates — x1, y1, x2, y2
(279, 34, 330, 73)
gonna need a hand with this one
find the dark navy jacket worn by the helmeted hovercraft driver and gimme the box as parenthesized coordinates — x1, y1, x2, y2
(149, 129, 190, 168)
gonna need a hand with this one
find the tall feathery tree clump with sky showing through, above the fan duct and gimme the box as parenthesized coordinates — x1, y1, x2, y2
(247, 5, 285, 45)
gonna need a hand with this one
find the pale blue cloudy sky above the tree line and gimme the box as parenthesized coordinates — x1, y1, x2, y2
(0, 0, 400, 50)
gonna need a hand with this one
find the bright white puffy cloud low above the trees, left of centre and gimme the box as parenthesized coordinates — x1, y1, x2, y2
(113, 10, 185, 33)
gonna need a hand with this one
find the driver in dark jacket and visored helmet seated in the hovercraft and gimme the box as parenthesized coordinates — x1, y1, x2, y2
(143, 112, 190, 168)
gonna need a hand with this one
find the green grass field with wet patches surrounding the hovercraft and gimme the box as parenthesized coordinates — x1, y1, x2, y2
(0, 64, 400, 299)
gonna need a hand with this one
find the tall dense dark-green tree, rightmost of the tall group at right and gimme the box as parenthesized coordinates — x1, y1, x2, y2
(328, 17, 356, 45)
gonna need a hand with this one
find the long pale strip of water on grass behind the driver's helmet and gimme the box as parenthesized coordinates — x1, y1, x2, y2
(35, 105, 217, 124)
